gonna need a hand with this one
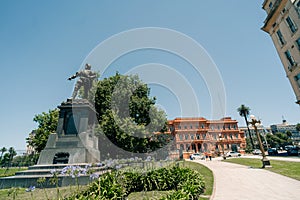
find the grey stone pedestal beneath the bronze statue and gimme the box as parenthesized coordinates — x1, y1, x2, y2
(38, 99, 100, 165)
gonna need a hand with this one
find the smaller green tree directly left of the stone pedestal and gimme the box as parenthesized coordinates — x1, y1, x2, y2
(26, 109, 58, 153)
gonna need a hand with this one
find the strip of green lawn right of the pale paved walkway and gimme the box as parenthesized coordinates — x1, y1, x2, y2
(224, 158, 300, 181)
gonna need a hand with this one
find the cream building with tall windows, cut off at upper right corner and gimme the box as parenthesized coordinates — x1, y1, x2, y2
(262, 0, 300, 104)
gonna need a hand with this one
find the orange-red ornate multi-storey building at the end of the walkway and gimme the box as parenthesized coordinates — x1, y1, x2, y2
(168, 117, 246, 157)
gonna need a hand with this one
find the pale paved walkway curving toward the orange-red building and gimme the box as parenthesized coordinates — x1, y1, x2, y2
(195, 159, 300, 200)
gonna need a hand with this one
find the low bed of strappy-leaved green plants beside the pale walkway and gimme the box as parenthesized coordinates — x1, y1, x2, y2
(69, 166, 205, 200)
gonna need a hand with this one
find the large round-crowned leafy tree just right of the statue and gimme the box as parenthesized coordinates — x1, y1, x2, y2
(95, 73, 169, 153)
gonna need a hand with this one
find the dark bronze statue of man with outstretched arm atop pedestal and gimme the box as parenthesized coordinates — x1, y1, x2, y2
(68, 63, 97, 99)
